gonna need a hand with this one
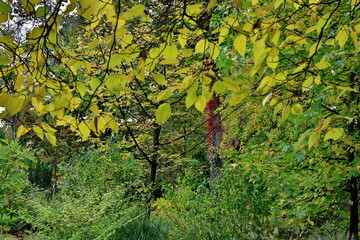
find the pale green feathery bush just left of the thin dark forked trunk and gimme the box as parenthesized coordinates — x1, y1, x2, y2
(20, 145, 161, 240)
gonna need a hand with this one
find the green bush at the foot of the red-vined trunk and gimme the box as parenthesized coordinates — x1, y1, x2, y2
(155, 163, 276, 240)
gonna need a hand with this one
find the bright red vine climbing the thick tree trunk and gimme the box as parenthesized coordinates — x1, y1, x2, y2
(206, 94, 223, 180)
